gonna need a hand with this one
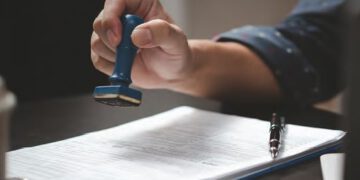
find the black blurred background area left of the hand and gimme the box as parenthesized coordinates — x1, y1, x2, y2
(0, 0, 105, 102)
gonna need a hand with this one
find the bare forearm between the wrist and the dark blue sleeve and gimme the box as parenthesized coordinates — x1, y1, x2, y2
(169, 40, 281, 102)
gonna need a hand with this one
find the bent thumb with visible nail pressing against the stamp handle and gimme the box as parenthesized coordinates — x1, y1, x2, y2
(131, 19, 187, 55)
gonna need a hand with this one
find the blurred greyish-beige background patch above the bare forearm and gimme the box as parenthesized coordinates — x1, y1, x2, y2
(161, 0, 297, 39)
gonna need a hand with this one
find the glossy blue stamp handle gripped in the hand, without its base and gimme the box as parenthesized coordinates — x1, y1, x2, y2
(109, 14, 144, 87)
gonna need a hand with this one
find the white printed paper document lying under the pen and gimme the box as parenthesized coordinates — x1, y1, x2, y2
(7, 107, 345, 180)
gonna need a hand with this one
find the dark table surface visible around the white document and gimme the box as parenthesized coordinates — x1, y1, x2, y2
(10, 91, 340, 180)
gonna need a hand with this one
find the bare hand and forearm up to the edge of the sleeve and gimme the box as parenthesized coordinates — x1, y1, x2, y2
(91, 0, 281, 102)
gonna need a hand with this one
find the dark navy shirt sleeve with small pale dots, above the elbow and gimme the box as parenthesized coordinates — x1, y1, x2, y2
(215, 0, 344, 105)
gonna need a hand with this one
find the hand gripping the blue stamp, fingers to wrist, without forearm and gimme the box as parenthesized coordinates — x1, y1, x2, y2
(91, 0, 193, 88)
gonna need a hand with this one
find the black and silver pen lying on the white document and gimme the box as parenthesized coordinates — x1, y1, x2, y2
(269, 113, 285, 159)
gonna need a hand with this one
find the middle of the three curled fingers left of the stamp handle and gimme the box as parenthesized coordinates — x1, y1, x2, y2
(91, 33, 115, 62)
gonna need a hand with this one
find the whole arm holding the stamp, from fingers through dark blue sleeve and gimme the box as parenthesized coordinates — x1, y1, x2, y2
(92, 0, 343, 105)
